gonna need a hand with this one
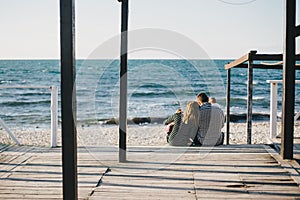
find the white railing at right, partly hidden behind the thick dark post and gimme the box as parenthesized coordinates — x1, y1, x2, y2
(267, 80, 300, 139)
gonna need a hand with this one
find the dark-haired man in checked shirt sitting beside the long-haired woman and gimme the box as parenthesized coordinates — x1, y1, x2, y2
(195, 93, 225, 146)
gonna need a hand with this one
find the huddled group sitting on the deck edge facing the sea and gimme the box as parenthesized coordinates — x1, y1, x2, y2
(164, 93, 224, 146)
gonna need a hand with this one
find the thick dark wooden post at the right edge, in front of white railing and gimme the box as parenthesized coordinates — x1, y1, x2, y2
(281, 0, 296, 159)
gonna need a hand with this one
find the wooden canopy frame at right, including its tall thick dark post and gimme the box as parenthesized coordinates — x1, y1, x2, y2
(225, 0, 300, 159)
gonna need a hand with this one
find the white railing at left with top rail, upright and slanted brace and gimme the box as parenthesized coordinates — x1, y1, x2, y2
(0, 85, 58, 147)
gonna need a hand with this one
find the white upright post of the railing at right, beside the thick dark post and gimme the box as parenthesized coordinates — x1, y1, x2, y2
(270, 82, 278, 139)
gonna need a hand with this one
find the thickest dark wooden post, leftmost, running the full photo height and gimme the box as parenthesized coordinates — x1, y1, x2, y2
(60, 0, 78, 199)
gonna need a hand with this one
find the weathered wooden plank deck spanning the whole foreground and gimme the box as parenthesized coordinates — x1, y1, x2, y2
(0, 145, 300, 199)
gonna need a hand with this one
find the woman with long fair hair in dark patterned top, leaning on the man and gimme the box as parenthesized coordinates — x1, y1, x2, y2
(165, 101, 199, 146)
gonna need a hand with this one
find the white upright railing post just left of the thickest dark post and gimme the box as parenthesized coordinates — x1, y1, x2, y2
(51, 86, 58, 147)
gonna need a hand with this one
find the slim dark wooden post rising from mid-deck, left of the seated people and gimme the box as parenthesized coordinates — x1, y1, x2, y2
(118, 0, 128, 162)
